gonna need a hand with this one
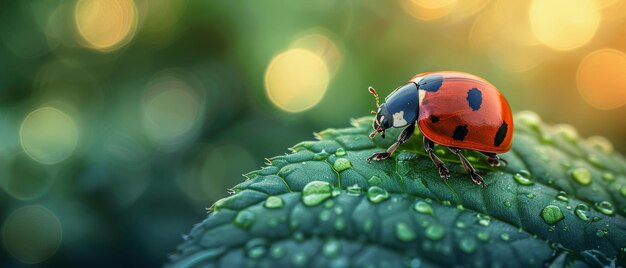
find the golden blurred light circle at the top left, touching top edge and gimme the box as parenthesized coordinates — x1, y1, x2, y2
(74, 0, 137, 51)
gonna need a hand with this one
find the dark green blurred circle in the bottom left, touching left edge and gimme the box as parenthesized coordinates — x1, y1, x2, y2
(2, 205, 62, 264)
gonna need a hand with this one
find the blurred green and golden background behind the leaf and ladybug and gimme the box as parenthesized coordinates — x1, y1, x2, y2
(0, 0, 626, 267)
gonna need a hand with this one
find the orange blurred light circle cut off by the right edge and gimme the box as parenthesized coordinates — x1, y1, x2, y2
(576, 49, 626, 110)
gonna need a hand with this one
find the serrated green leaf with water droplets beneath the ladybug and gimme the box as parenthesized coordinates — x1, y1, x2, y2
(169, 112, 626, 267)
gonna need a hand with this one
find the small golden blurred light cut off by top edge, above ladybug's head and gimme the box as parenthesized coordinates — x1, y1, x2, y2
(400, 0, 457, 21)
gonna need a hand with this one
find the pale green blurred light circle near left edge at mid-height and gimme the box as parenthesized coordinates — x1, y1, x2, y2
(20, 107, 78, 165)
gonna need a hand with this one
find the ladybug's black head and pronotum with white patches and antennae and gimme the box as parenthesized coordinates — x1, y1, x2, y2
(369, 82, 419, 138)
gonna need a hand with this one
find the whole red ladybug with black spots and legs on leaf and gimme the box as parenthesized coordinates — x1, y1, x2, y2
(367, 71, 513, 187)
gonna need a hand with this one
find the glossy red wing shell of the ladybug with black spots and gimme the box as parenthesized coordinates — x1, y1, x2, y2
(410, 71, 513, 153)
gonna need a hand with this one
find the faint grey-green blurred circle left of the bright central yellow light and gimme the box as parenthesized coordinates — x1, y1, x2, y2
(142, 71, 205, 147)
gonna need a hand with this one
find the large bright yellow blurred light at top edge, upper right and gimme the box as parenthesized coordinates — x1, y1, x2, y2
(529, 0, 602, 50)
